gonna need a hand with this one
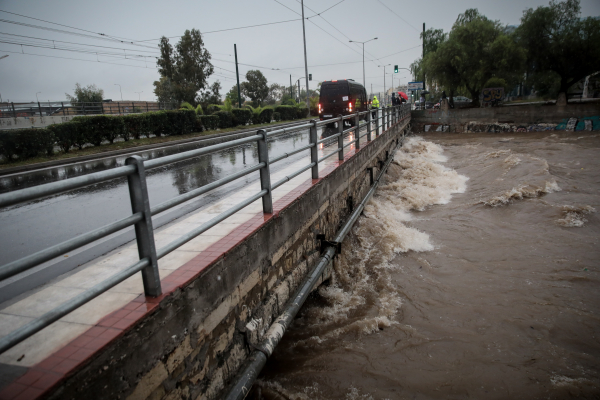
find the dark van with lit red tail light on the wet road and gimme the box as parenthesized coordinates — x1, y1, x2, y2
(319, 79, 369, 126)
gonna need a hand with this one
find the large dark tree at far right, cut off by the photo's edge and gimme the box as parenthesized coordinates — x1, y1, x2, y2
(516, 0, 600, 102)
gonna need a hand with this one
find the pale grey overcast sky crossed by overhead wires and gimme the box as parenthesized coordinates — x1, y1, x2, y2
(0, 0, 600, 102)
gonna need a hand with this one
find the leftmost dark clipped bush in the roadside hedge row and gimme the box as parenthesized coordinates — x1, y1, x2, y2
(0, 128, 54, 162)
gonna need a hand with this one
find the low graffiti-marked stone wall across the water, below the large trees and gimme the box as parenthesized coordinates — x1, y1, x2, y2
(412, 102, 600, 133)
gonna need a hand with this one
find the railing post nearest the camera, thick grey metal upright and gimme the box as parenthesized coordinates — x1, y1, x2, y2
(125, 156, 162, 297)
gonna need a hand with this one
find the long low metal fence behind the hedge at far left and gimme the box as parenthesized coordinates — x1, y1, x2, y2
(0, 101, 179, 118)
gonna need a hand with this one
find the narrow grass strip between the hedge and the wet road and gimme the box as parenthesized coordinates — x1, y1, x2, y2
(0, 117, 314, 170)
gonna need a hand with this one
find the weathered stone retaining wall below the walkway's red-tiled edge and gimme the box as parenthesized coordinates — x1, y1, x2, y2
(49, 122, 408, 400)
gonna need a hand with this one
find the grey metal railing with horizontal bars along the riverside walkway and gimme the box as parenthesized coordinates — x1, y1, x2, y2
(0, 102, 410, 353)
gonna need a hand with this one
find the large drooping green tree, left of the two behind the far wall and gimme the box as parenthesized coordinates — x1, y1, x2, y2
(423, 9, 525, 106)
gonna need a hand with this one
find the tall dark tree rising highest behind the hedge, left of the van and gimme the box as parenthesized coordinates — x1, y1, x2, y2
(154, 29, 214, 104)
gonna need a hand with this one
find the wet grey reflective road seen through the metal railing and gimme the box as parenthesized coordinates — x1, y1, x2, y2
(0, 120, 366, 265)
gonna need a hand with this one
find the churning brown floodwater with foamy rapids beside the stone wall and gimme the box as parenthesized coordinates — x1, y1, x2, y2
(254, 132, 600, 400)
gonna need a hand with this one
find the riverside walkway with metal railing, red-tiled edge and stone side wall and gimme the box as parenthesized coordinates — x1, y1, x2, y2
(0, 105, 410, 399)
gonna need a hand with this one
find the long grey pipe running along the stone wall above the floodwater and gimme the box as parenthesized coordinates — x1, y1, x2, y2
(225, 130, 404, 400)
